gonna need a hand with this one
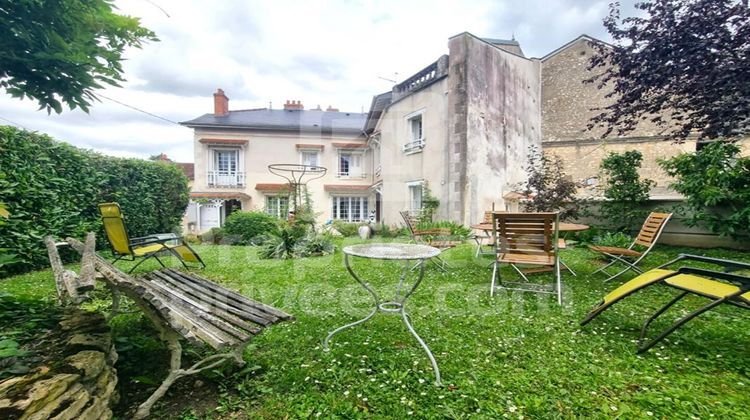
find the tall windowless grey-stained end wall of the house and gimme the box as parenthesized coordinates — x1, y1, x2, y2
(448, 33, 541, 224)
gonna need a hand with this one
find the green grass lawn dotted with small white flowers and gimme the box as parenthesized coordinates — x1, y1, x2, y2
(0, 240, 750, 418)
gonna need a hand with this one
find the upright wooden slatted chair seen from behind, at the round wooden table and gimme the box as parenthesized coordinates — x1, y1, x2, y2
(490, 212, 562, 305)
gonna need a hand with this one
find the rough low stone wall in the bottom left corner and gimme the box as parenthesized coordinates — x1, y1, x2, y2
(0, 308, 118, 420)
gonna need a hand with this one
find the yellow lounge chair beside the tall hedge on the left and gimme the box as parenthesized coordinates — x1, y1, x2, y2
(99, 203, 206, 273)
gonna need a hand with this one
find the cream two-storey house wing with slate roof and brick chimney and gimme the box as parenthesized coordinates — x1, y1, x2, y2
(181, 89, 374, 232)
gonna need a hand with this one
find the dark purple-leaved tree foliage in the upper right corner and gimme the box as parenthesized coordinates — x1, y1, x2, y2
(589, 0, 750, 140)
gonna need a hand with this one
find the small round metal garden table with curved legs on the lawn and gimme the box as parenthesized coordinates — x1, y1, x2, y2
(323, 243, 442, 386)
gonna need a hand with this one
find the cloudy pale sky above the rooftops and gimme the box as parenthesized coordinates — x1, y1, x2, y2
(0, 0, 632, 162)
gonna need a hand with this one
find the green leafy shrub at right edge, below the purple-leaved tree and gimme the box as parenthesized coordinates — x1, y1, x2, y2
(659, 142, 750, 239)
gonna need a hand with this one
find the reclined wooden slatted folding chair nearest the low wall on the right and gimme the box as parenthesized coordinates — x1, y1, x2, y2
(589, 212, 672, 281)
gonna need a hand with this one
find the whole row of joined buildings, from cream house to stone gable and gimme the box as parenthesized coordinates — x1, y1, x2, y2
(182, 33, 747, 231)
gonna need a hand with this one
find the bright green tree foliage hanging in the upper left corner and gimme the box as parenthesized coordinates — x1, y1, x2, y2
(0, 0, 157, 113)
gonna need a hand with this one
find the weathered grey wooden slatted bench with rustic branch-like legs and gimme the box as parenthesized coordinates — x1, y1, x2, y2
(46, 234, 292, 418)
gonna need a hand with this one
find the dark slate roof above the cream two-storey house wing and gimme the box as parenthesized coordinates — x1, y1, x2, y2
(180, 108, 367, 135)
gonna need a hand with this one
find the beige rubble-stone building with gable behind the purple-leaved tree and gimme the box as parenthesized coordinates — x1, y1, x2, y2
(541, 35, 748, 192)
